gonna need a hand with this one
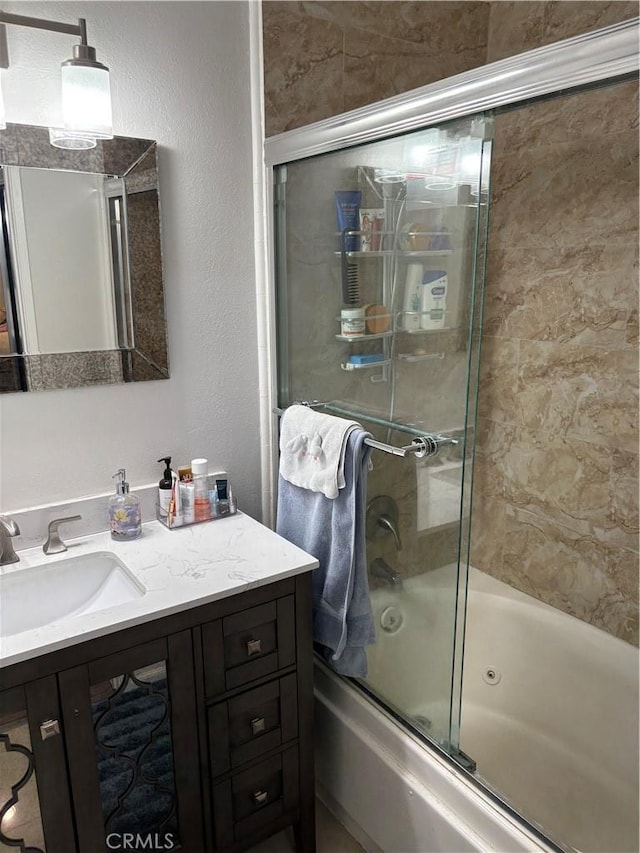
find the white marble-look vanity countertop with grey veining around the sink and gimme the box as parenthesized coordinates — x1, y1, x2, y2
(0, 512, 318, 667)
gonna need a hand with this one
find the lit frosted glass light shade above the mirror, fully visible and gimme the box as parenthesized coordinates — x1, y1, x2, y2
(62, 60, 113, 139)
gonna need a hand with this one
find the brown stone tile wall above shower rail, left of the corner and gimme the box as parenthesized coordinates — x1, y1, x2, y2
(262, 0, 489, 136)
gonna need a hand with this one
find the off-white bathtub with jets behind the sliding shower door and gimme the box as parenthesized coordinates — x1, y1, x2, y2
(315, 567, 638, 853)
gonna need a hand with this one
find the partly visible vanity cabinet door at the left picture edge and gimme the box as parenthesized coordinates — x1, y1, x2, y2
(0, 676, 76, 853)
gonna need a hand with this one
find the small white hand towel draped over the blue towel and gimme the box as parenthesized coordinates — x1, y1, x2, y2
(280, 405, 360, 498)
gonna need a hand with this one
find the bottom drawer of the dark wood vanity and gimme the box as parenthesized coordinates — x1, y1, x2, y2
(213, 746, 298, 848)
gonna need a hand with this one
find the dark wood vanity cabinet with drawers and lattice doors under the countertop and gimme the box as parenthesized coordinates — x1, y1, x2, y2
(0, 573, 315, 853)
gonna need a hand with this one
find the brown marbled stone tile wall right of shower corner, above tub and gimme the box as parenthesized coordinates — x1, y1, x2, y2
(472, 8, 638, 643)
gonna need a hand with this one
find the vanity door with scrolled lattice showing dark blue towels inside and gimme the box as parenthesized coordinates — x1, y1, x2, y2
(58, 631, 204, 853)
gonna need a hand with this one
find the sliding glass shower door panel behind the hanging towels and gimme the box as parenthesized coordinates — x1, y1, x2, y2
(274, 115, 492, 754)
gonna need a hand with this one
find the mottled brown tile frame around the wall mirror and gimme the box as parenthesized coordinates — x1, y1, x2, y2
(0, 123, 169, 393)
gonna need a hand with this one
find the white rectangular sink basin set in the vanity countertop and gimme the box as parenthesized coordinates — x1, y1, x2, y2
(0, 551, 146, 637)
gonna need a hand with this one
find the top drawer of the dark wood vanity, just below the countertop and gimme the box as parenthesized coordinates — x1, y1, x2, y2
(202, 595, 296, 698)
